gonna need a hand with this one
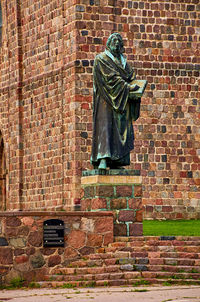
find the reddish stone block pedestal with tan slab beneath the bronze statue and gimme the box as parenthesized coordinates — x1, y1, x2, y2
(81, 170, 143, 236)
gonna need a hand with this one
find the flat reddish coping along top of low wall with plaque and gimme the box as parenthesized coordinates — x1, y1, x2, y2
(0, 211, 113, 217)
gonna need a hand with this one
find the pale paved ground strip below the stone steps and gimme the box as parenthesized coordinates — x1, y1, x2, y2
(0, 286, 200, 302)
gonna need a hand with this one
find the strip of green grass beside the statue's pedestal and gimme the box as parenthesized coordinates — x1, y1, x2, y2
(143, 220, 200, 236)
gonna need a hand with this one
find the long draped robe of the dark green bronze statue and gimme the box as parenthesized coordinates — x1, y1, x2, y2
(91, 51, 140, 166)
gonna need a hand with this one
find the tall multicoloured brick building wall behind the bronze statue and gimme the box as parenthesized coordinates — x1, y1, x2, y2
(0, 0, 200, 218)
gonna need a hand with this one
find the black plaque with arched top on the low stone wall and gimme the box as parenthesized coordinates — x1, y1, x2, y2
(43, 219, 65, 247)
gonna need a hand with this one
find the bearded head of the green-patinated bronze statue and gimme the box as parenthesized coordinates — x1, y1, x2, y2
(106, 33, 124, 56)
